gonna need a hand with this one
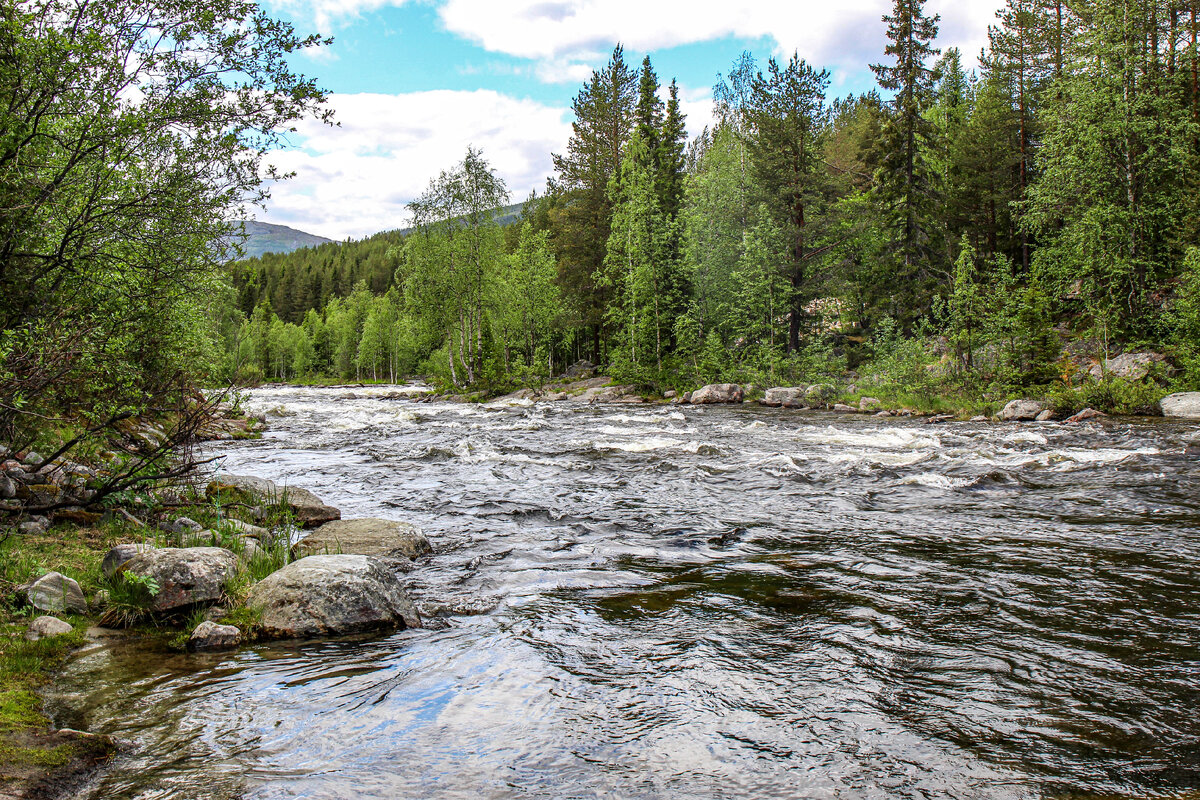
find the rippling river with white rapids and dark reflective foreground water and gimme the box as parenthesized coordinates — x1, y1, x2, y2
(52, 389, 1200, 800)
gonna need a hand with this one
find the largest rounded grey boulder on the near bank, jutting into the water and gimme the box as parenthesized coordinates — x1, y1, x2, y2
(246, 554, 421, 639)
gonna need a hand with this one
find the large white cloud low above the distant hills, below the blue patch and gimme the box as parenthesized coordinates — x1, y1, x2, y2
(260, 90, 571, 239)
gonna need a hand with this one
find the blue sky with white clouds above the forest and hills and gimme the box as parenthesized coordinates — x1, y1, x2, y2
(254, 0, 1002, 240)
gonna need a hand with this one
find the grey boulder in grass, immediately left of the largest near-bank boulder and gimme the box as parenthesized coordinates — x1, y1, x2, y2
(118, 547, 238, 612)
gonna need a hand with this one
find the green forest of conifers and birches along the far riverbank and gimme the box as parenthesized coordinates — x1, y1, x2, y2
(226, 0, 1200, 389)
